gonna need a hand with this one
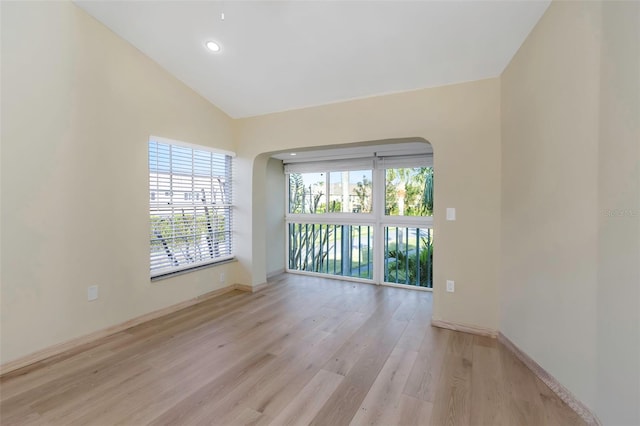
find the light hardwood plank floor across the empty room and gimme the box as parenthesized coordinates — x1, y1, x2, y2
(0, 275, 583, 426)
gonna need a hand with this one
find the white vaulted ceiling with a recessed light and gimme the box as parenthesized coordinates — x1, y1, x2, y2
(76, 0, 550, 118)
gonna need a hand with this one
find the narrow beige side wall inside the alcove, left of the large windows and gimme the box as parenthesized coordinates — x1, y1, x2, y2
(264, 158, 285, 275)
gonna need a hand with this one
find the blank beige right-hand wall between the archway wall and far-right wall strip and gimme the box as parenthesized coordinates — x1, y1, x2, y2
(500, 2, 600, 406)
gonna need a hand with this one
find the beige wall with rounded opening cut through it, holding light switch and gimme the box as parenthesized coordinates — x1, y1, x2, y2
(238, 79, 500, 330)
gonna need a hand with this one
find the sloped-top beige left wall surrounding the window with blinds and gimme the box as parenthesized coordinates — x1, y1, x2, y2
(0, 2, 237, 363)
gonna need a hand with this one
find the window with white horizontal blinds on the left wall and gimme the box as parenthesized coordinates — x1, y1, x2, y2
(149, 138, 233, 278)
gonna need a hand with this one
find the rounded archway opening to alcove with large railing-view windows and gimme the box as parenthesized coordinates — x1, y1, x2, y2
(253, 138, 435, 289)
